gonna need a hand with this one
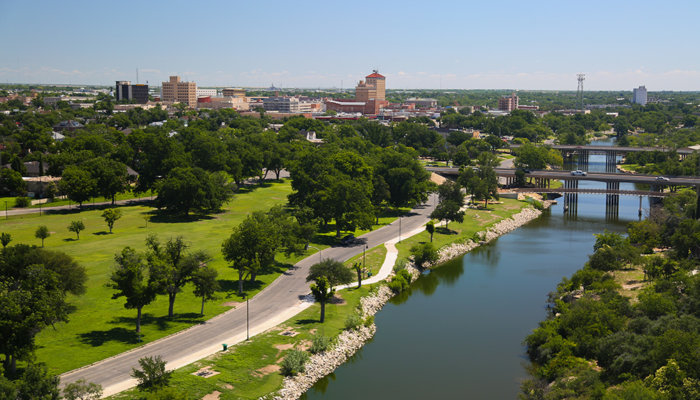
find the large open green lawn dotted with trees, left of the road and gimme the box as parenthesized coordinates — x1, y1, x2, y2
(0, 182, 402, 374)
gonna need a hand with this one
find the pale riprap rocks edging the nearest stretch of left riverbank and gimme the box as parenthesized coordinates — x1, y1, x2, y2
(274, 285, 394, 400)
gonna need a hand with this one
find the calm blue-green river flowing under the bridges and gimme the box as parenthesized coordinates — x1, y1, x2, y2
(303, 139, 648, 400)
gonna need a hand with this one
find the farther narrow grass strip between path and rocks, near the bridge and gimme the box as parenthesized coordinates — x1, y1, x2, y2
(396, 199, 528, 262)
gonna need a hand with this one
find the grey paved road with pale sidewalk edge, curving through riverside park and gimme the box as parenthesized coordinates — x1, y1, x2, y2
(61, 195, 437, 395)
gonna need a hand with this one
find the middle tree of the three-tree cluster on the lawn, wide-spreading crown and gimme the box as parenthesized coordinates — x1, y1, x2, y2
(146, 235, 210, 318)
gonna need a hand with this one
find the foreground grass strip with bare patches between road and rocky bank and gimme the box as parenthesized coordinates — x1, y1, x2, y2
(110, 285, 372, 399)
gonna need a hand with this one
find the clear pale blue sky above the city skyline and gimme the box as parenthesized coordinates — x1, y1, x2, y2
(0, 0, 700, 91)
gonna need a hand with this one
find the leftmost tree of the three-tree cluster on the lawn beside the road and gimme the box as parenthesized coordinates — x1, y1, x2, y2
(107, 247, 158, 334)
